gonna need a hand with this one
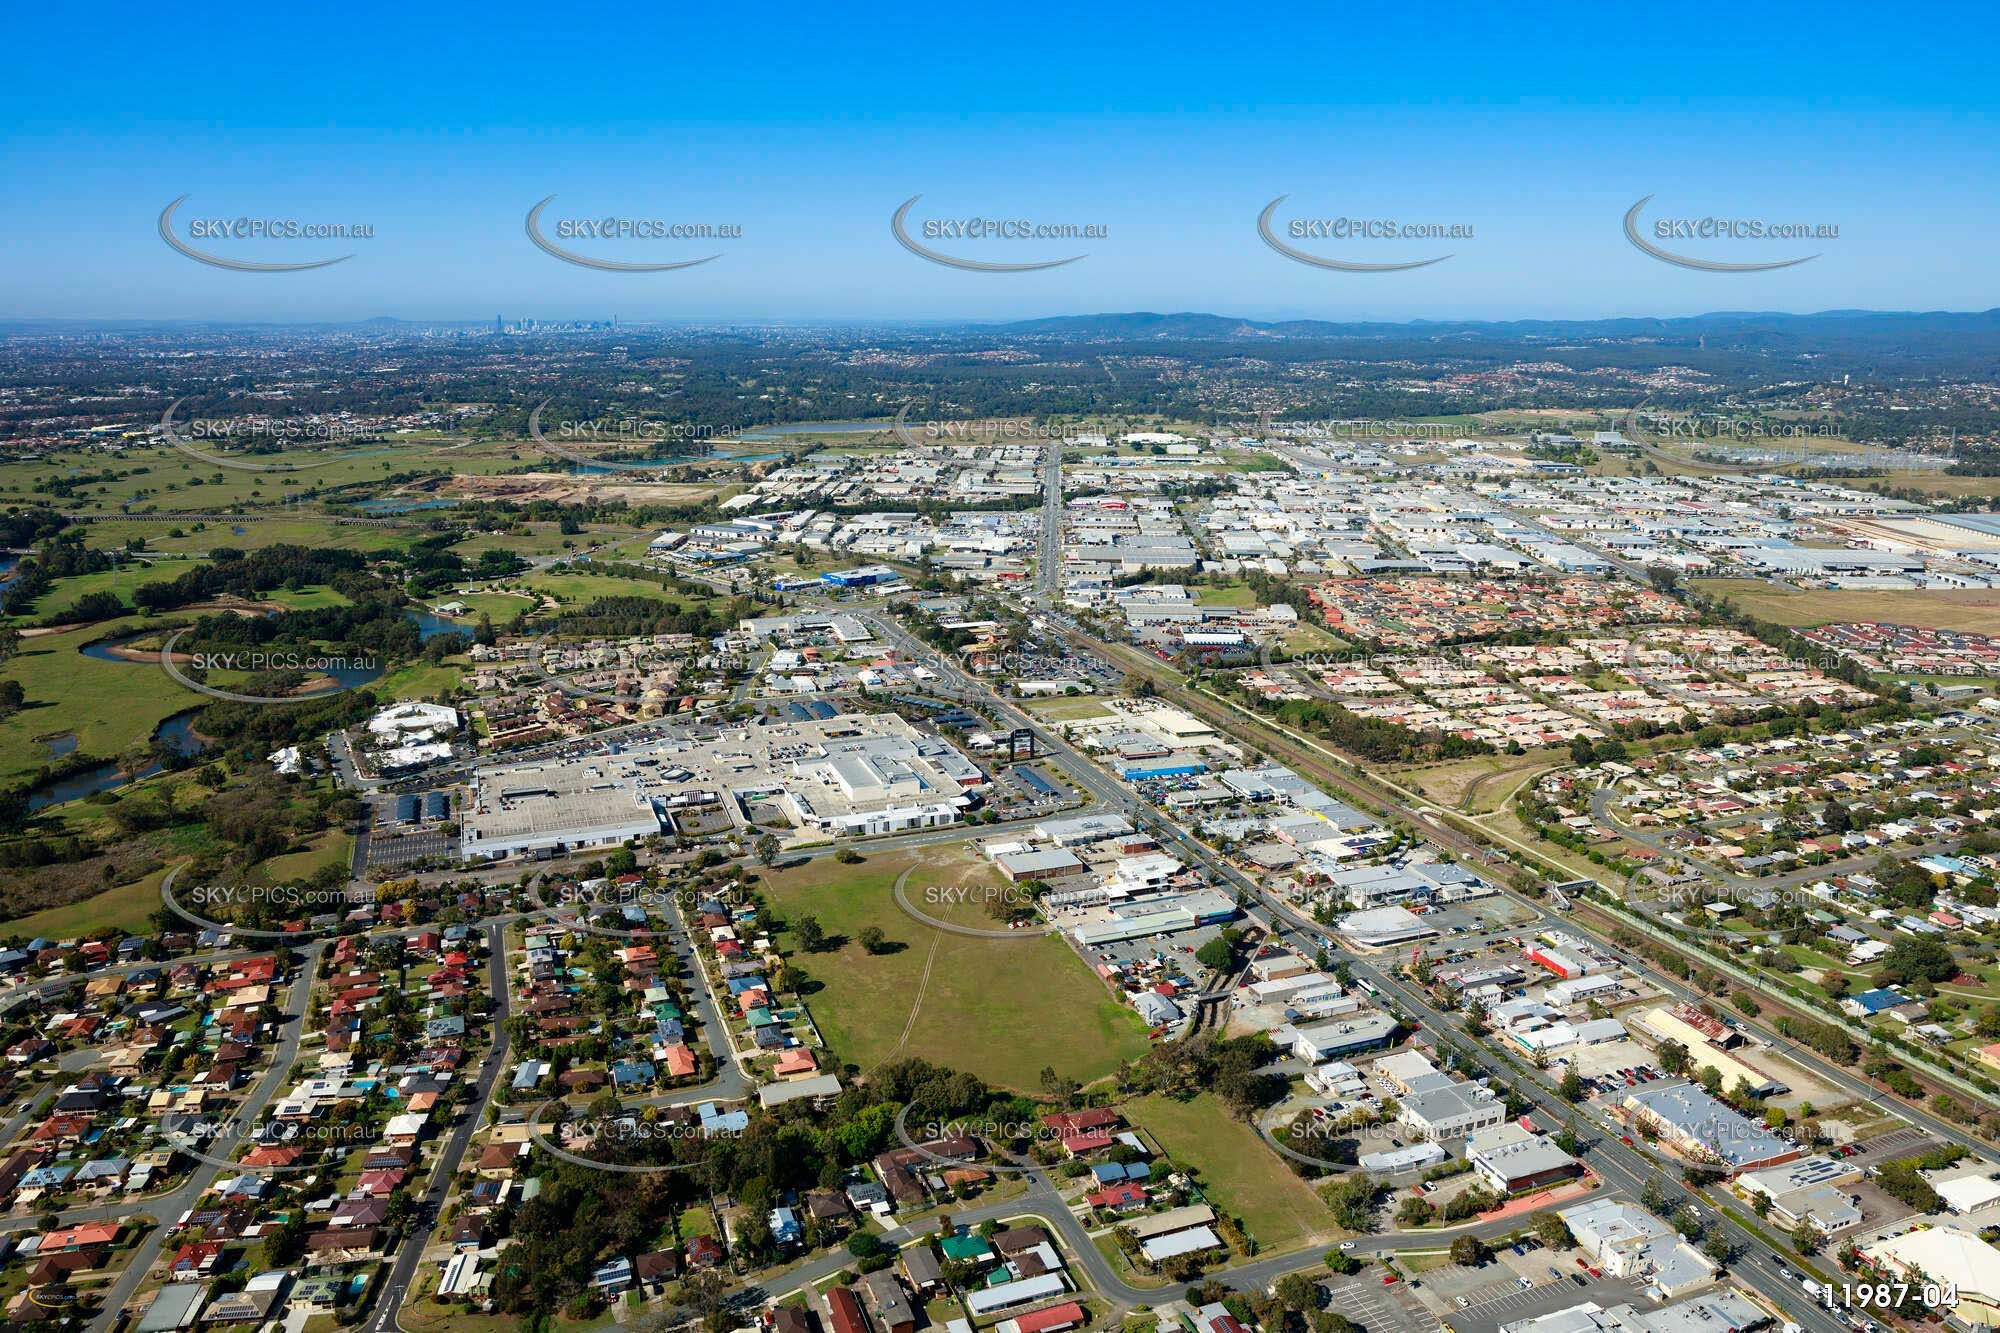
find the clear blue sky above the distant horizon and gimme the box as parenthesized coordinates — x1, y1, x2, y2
(0, 0, 2000, 320)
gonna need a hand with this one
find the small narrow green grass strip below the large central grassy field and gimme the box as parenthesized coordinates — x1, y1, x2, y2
(1124, 1093, 1338, 1253)
